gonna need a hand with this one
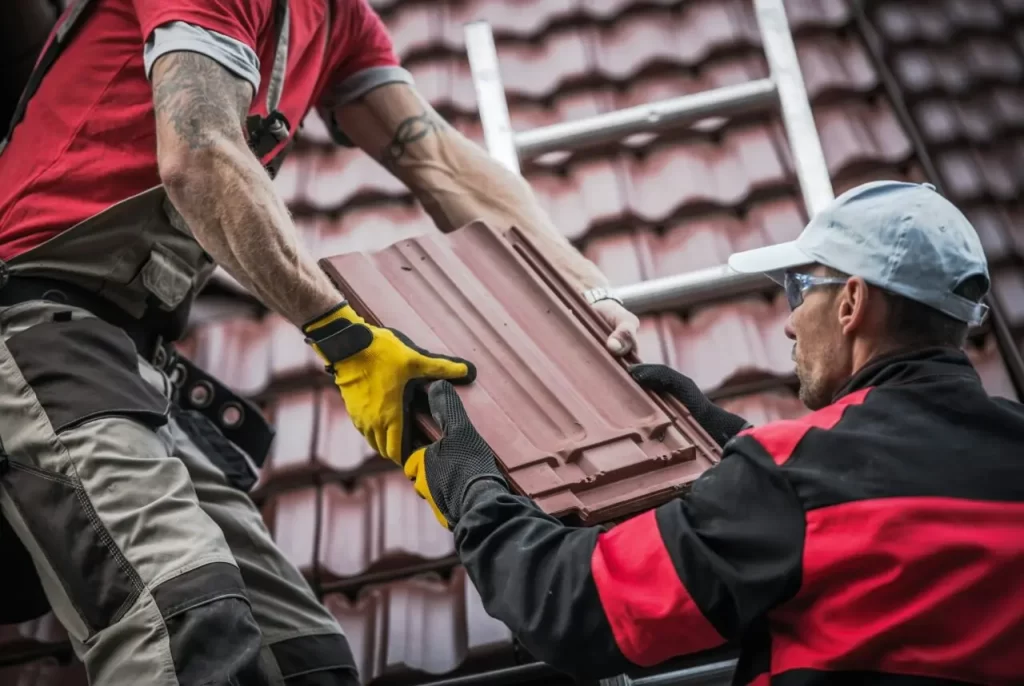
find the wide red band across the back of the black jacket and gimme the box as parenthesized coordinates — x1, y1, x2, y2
(771, 498, 1024, 685)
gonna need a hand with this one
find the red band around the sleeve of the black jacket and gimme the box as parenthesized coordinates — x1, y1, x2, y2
(591, 510, 725, 667)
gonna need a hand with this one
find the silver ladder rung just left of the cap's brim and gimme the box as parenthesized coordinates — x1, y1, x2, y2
(612, 264, 772, 314)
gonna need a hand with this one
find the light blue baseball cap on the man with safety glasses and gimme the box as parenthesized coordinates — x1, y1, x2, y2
(729, 181, 991, 326)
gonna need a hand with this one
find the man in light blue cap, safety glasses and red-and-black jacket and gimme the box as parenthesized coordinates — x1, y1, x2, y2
(409, 182, 1024, 686)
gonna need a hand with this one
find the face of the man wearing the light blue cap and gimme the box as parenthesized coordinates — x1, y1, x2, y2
(785, 267, 853, 410)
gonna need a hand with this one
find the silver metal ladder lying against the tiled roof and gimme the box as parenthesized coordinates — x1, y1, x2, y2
(465, 0, 835, 313)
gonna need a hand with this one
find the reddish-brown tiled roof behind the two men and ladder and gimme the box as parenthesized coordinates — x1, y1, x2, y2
(0, 0, 1024, 686)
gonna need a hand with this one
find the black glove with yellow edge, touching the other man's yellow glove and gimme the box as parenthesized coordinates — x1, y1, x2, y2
(402, 381, 508, 530)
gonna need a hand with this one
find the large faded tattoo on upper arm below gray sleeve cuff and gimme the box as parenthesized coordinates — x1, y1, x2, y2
(153, 52, 252, 151)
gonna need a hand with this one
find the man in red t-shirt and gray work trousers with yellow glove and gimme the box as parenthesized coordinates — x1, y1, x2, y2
(0, 0, 638, 686)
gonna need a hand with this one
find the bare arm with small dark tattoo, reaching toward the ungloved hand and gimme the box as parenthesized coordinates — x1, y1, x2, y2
(334, 84, 608, 290)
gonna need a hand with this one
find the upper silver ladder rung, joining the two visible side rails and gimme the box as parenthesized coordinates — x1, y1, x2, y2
(515, 79, 778, 159)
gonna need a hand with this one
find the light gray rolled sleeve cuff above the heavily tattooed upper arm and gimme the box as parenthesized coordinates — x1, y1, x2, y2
(142, 22, 260, 93)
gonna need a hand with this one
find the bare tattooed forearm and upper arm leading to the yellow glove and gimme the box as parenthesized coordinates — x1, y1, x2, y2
(153, 52, 342, 326)
